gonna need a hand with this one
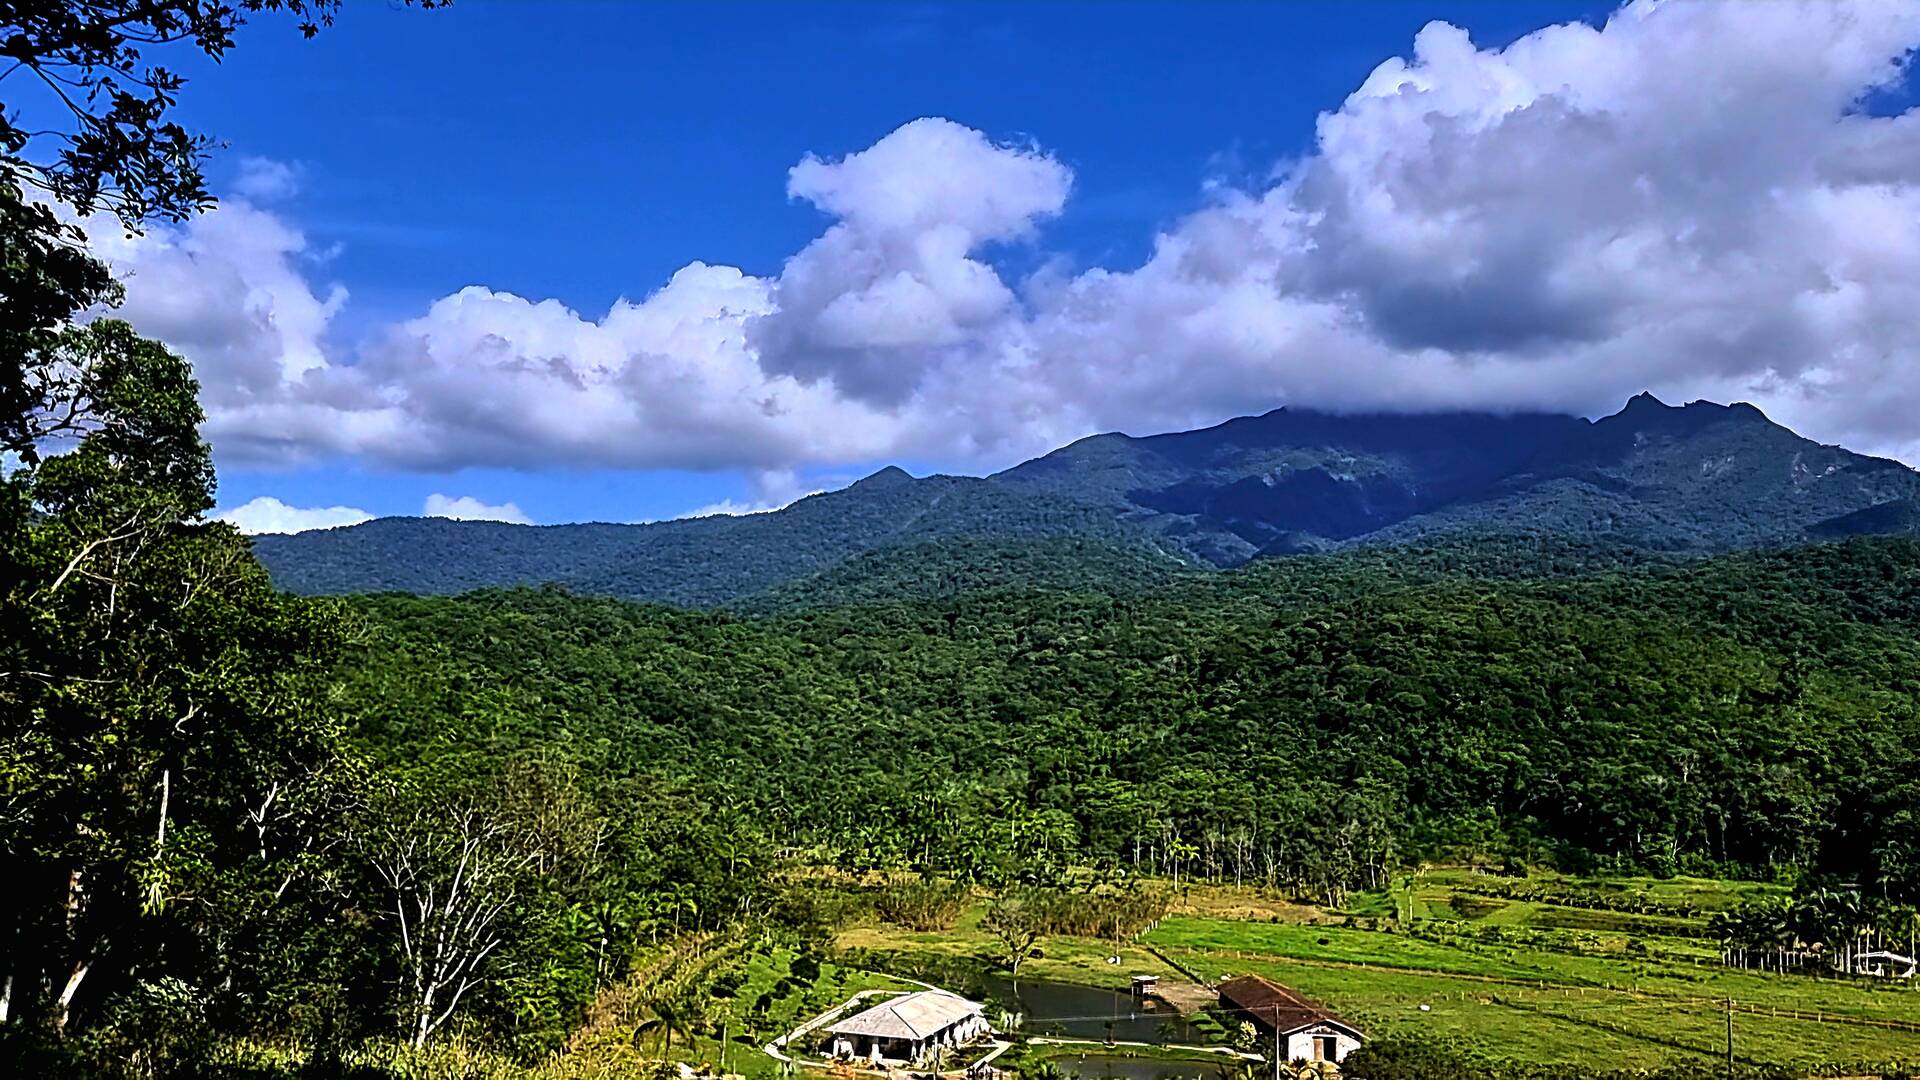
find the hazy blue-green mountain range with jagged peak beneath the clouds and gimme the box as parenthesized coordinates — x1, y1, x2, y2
(255, 394, 1920, 605)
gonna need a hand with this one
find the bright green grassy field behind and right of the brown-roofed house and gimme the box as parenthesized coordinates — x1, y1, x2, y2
(837, 871, 1920, 1070)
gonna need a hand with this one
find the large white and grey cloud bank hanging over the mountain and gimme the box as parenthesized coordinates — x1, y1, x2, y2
(78, 0, 1920, 477)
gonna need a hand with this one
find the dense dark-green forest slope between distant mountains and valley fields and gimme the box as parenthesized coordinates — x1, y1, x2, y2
(337, 540, 1920, 888)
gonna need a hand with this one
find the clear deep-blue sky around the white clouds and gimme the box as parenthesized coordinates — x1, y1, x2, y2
(188, 0, 1607, 521)
